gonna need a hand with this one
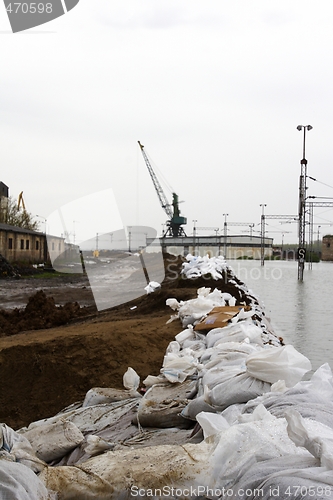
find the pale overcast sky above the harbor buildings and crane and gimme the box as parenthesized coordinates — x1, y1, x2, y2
(0, 0, 333, 244)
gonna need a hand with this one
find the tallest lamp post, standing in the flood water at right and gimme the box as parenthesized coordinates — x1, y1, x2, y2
(297, 125, 313, 281)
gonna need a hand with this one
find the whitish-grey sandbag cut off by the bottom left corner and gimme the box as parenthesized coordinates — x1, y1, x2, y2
(0, 459, 52, 500)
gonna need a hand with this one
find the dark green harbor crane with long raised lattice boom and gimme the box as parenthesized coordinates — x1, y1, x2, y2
(138, 141, 187, 238)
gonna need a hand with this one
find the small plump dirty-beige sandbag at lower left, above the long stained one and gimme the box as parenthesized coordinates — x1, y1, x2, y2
(23, 419, 84, 462)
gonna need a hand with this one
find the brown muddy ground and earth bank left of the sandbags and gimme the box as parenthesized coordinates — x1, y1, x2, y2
(0, 254, 249, 429)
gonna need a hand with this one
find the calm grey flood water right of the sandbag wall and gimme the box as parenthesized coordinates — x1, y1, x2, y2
(228, 261, 333, 370)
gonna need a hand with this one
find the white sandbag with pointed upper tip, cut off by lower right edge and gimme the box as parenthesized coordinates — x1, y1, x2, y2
(285, 409, 333, 470)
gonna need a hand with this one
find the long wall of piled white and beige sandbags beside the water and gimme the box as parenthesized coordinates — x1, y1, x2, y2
(0, 256, 333, 500)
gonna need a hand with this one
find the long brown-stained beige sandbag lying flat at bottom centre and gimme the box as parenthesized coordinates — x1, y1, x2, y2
(40, 442, 210, 500)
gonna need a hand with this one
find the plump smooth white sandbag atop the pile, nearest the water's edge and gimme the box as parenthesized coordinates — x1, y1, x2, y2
(246, 345, 311, 387)
